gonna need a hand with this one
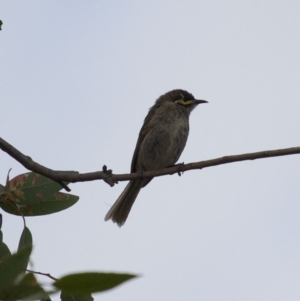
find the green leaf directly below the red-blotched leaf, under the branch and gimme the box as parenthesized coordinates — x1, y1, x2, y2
(0, 192, 79, 216)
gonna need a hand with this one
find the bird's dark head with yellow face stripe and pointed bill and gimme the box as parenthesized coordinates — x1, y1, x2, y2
(156, 89, 208, 113)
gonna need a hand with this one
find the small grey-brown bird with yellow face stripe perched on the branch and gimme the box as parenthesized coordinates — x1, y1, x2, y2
(105, 89, 207, 227)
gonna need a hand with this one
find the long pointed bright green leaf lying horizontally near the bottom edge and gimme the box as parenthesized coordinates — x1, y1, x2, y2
(53, 273, 136, 294)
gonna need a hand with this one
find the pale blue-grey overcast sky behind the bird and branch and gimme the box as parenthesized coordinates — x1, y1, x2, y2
(0, 0, 300, 301)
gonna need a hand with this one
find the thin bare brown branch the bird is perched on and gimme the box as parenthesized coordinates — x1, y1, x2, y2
(0, 138, 300, 188)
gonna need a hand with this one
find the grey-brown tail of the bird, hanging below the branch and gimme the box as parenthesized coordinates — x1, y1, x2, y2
(104, 180, 143, 227)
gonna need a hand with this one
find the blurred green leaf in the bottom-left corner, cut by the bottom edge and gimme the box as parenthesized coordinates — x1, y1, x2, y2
(0, 273, 50, 300)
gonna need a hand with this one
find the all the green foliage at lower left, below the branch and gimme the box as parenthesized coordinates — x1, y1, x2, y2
(0, 172, 136, 301)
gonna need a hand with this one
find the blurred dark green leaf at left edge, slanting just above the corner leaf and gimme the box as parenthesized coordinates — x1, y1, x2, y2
(0, 246, 32, 292)
